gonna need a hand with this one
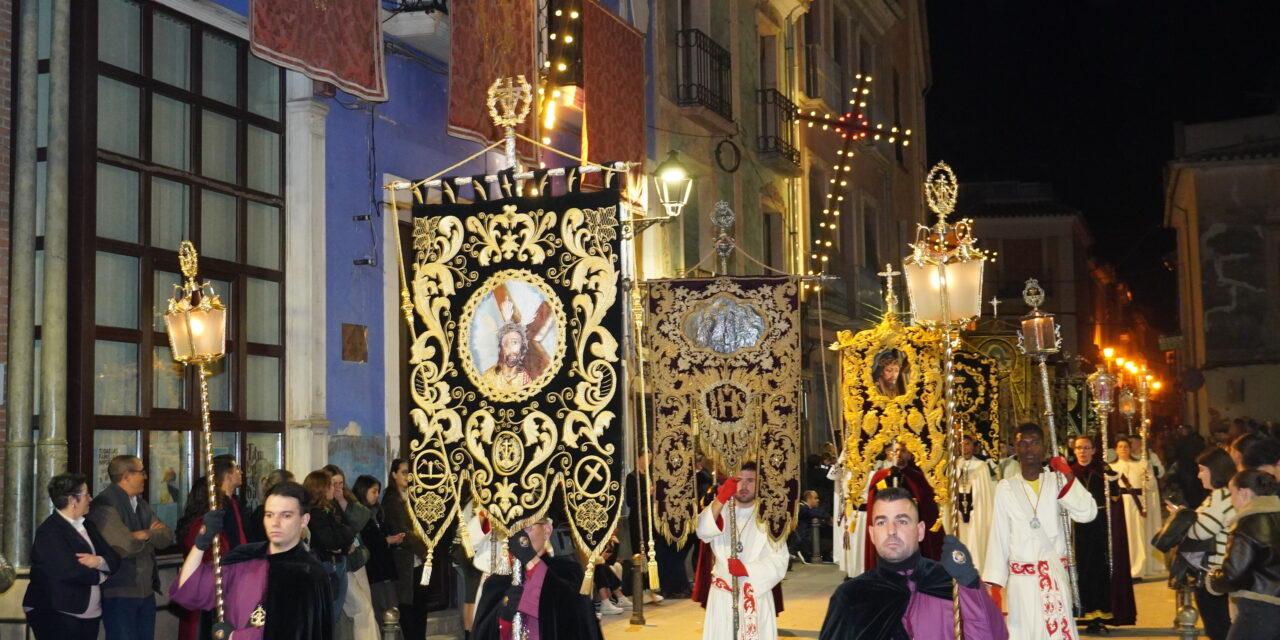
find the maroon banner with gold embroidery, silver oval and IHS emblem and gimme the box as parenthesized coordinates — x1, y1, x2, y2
(645, 276, 800, 543)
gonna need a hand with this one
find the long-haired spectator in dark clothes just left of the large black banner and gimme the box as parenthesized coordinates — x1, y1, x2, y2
(383, 458, 426, 640)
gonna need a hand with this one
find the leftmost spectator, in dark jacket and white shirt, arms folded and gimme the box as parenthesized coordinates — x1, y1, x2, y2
(22, 474, 120, 640)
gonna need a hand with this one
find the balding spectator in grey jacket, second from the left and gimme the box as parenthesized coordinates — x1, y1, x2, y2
(88, 456, 174, 640)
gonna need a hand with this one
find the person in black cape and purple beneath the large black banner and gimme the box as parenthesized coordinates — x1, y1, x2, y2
(471, 518, 604, 640)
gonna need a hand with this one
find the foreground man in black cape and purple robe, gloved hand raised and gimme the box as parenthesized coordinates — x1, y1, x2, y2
(818, 486, 1009, 640)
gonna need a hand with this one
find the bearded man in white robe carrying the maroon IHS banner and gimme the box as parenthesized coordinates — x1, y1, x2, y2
(698, 462, 787, 640)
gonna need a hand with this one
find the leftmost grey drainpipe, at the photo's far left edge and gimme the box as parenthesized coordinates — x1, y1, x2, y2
(4, 0, 40, 567)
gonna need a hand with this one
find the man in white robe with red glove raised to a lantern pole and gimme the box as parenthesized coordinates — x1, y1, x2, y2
(982, 422, 1098, 640)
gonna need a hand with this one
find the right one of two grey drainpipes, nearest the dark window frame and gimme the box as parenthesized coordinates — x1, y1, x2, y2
(36, 0, 72, 520)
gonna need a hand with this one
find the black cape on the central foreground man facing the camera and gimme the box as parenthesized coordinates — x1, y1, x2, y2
(818, 552, 954, 640)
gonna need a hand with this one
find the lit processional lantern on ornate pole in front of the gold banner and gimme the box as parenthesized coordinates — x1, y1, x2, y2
(902, 163, 987, 639)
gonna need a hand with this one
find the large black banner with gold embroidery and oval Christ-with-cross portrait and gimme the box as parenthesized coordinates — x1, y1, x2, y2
(404, 172, 625, 570)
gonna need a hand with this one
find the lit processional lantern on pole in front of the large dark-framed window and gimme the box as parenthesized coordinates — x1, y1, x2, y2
(164, 241, 227, 623)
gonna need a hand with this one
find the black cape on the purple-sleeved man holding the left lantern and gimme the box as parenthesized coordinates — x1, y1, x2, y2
(221, 543, 334, 640)
